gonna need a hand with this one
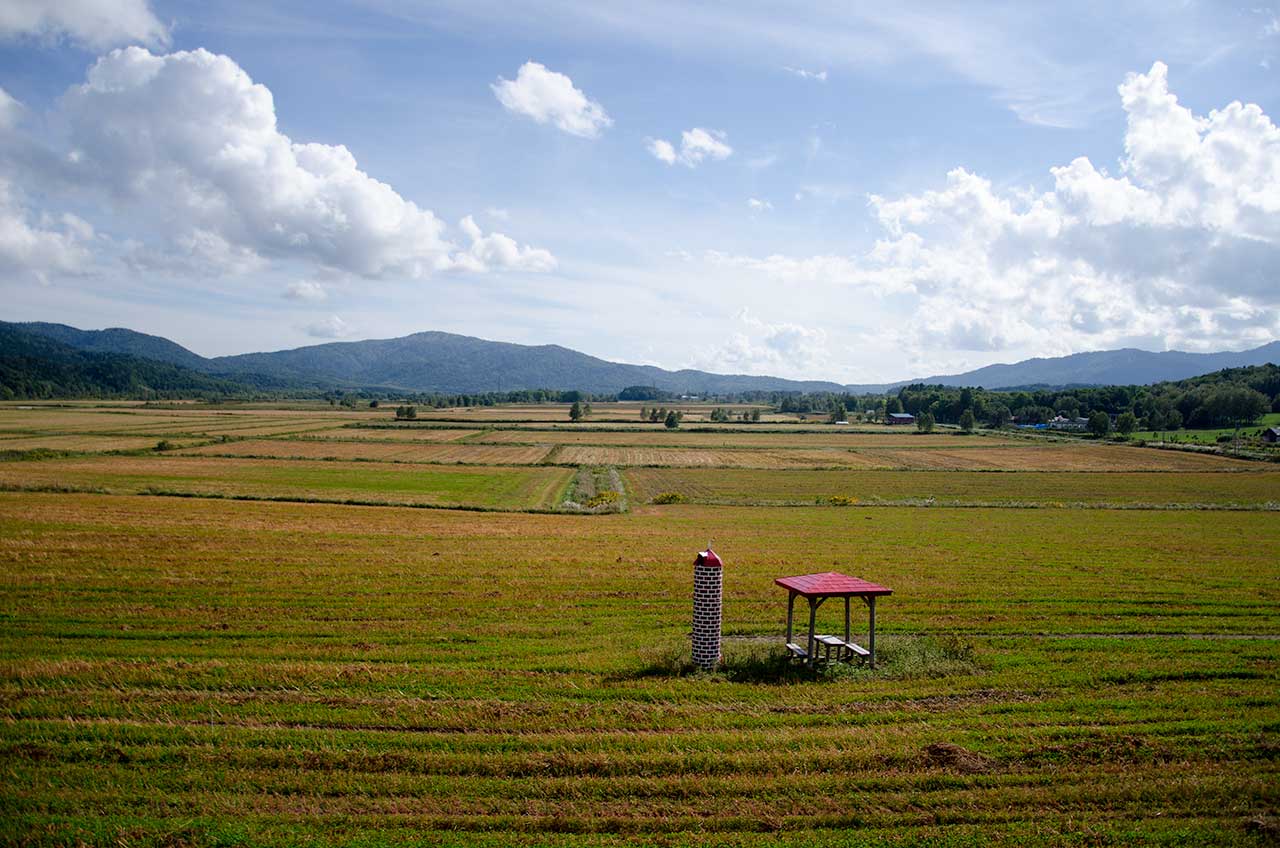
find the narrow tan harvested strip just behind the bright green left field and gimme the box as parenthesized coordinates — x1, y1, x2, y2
(186, 439, 550, 465)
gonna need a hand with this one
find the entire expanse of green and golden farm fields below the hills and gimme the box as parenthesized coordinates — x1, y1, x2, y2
(0, 405, 1280, 848)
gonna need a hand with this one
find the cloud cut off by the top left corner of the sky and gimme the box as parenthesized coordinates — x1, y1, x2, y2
(0, 0, 169, 49)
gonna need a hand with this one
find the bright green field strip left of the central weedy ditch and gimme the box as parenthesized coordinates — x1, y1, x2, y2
(0, 455, 573, 510)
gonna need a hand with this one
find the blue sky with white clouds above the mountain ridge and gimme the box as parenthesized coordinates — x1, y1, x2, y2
(0, 0, 1280, 382)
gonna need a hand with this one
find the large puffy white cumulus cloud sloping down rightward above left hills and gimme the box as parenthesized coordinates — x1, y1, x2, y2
(35, 47, 550, 278)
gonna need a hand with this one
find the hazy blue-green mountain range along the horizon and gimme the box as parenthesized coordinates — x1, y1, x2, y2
(0, 322, 1280, 395)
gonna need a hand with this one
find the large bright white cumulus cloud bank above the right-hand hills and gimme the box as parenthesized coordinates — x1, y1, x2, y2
(708, 63, 1280, 355)
